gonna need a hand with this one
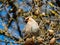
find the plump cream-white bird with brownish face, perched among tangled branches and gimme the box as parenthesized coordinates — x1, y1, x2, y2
(23, 16, 39, 36)
